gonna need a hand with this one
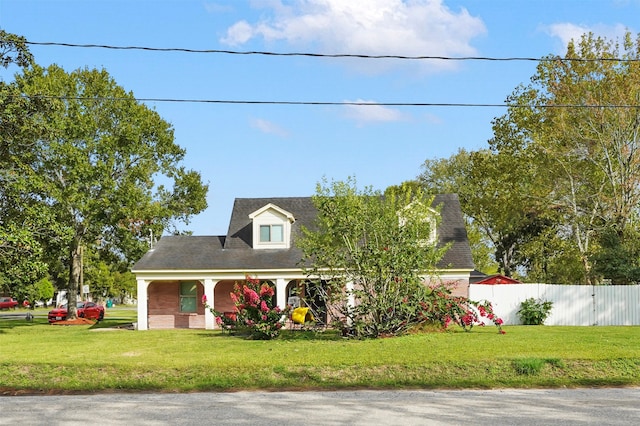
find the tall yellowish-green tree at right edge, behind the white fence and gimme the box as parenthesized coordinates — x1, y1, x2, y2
(492, 33, 640, 283)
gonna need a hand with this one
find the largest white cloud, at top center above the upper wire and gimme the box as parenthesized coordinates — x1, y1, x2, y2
(221, 0, 486, 72)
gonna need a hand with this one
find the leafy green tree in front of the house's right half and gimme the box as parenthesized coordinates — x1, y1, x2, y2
(296, 179, 446, 337)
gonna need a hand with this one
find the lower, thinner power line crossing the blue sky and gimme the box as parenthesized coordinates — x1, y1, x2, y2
(19, 95, 640, 109)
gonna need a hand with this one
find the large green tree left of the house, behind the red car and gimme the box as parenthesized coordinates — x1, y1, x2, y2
(14, 65, 208, 318)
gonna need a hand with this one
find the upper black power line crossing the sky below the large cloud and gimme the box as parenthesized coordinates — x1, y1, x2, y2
(25, 41, 640, 62)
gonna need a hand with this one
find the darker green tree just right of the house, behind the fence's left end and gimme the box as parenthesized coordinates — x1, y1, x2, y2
(418, 149, 549, 275)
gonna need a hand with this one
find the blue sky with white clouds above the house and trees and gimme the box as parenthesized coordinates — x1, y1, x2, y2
(0, 0, 640, 235)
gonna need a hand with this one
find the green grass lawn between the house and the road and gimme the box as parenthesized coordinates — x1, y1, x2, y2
(0, 307, 640, 394)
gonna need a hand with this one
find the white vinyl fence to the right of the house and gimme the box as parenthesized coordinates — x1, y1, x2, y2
(469, 284, 640, 325)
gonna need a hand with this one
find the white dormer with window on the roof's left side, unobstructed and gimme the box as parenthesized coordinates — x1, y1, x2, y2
(249, 203, 296, 249)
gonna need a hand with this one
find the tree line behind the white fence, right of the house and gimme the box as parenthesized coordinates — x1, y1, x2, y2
(416, 33, 640, 284)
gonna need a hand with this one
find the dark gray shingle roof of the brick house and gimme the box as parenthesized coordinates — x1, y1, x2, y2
(132, 194, 474, 271)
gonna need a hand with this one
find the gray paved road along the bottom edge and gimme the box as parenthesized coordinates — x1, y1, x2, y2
(0, 388, 640, 426)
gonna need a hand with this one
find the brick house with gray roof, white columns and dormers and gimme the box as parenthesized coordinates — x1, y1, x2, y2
(132, 194, 474, 330)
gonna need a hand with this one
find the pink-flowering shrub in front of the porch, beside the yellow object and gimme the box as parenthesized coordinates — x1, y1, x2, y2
(202, 276, 285, 340)
